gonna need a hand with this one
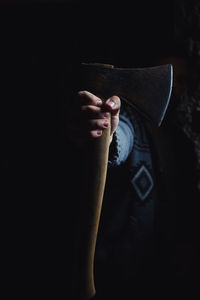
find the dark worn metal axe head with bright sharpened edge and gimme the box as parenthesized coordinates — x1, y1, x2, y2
(80, 63, 173, 126)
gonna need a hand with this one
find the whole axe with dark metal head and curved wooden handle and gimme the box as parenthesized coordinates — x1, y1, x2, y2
(75, 63, 172, 300)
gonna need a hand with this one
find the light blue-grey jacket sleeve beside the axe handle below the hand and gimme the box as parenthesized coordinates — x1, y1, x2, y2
(108, 109, 134, 167)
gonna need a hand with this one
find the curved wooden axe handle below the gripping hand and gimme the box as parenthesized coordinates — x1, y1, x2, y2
(75, 115, 110, 300)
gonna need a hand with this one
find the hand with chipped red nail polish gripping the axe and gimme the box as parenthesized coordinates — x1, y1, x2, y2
(67, 91, 121, 145)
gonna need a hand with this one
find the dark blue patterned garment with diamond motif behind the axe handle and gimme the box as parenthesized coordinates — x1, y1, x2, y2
(95, 100, 156, 290)
